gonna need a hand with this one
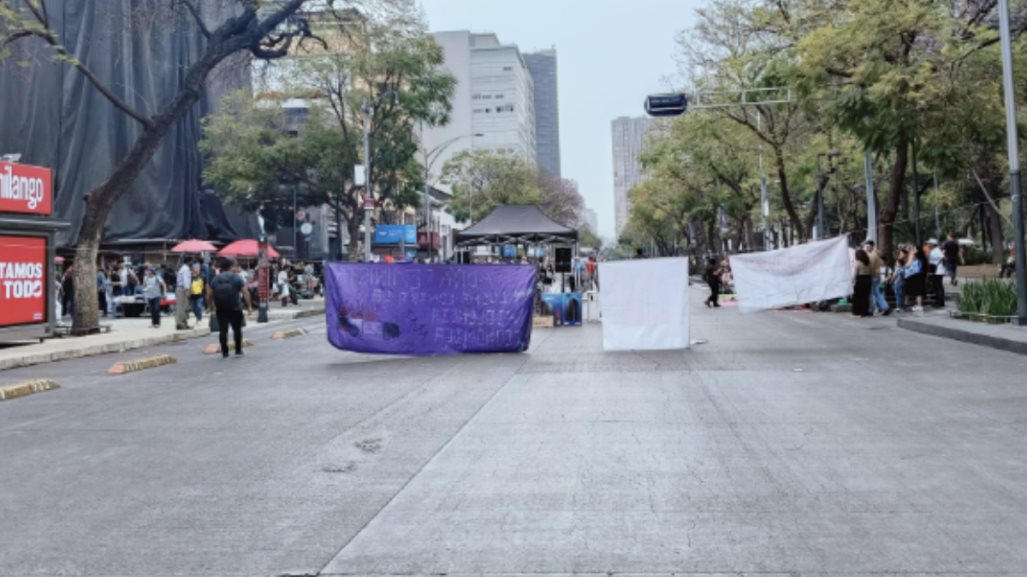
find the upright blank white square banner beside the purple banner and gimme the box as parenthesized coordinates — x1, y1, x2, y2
(599, 259, 688, 350)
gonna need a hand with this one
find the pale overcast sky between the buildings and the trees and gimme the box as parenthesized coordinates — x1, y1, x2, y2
(420, 0, 703, 237)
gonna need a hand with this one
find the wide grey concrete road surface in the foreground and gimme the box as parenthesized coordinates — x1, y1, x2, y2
(0, 291, 1027, 577)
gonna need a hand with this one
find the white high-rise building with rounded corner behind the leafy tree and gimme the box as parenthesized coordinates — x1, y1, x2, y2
(422, 31, 536, 179)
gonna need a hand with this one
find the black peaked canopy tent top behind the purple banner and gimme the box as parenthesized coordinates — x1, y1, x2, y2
(456, 204, 577, 246)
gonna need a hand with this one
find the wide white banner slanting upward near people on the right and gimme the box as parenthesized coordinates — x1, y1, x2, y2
(731, 236, 852, 312)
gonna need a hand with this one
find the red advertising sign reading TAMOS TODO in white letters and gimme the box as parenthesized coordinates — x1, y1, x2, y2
(0, 232, 48, 326)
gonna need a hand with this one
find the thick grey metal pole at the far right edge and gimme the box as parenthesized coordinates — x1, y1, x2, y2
(998, 0, 1027, 326)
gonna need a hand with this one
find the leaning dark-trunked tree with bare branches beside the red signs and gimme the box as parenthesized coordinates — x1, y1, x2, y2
(0, 0, 343, 334)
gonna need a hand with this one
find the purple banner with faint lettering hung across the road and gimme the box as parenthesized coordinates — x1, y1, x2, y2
(325, 263, 535, 356)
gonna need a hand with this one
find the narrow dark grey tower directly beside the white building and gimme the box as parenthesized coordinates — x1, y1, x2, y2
(524, 49, 562, 177)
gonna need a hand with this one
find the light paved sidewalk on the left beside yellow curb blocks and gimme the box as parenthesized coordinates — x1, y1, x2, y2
(0, 298, 325, 371)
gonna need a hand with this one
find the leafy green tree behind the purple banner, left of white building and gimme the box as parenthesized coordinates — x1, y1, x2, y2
(204, 7, 455, 255)
